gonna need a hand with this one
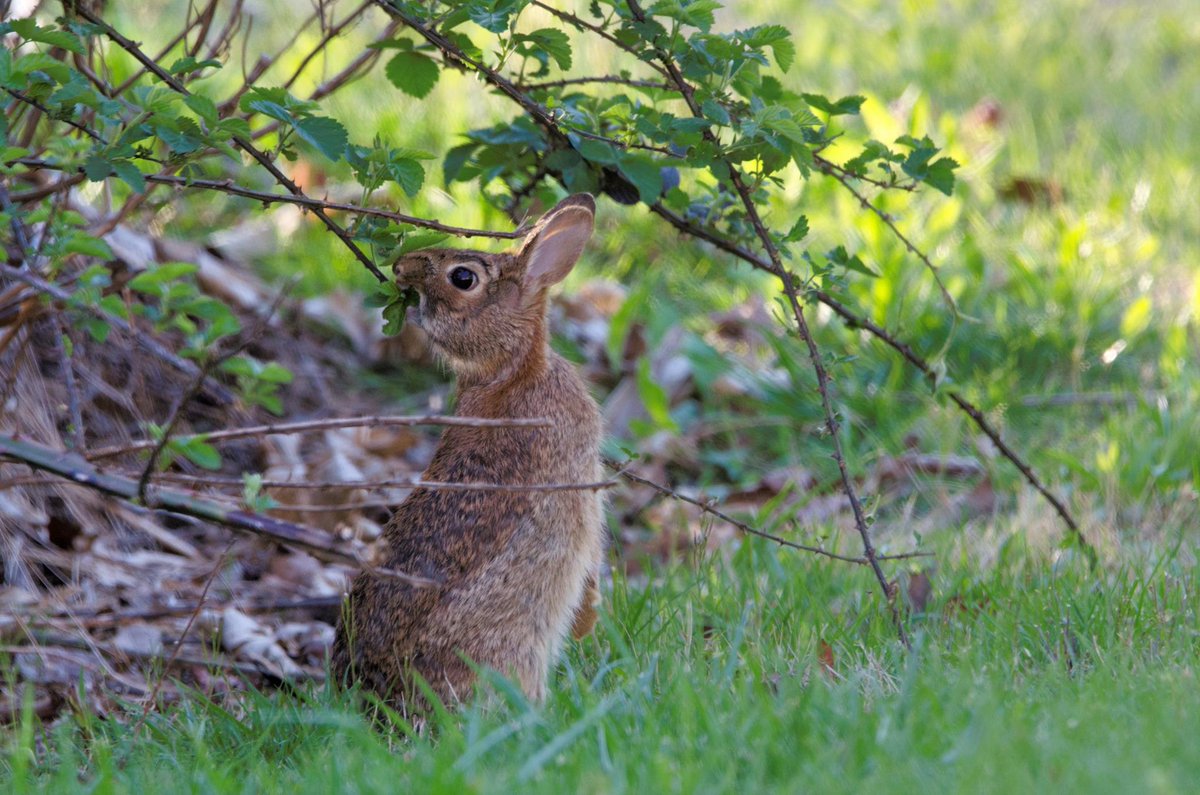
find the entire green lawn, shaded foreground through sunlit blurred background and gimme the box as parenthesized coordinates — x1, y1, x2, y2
(0, 0, 1200, 793)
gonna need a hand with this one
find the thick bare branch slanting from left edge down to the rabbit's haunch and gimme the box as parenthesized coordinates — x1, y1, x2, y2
(0, 435, 438, 587)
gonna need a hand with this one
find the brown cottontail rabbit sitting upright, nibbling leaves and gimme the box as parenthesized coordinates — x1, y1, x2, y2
(332, 195, 604, 712)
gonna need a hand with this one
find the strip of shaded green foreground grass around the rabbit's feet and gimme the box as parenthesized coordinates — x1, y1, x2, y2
(5, 536, 1200, 793)
